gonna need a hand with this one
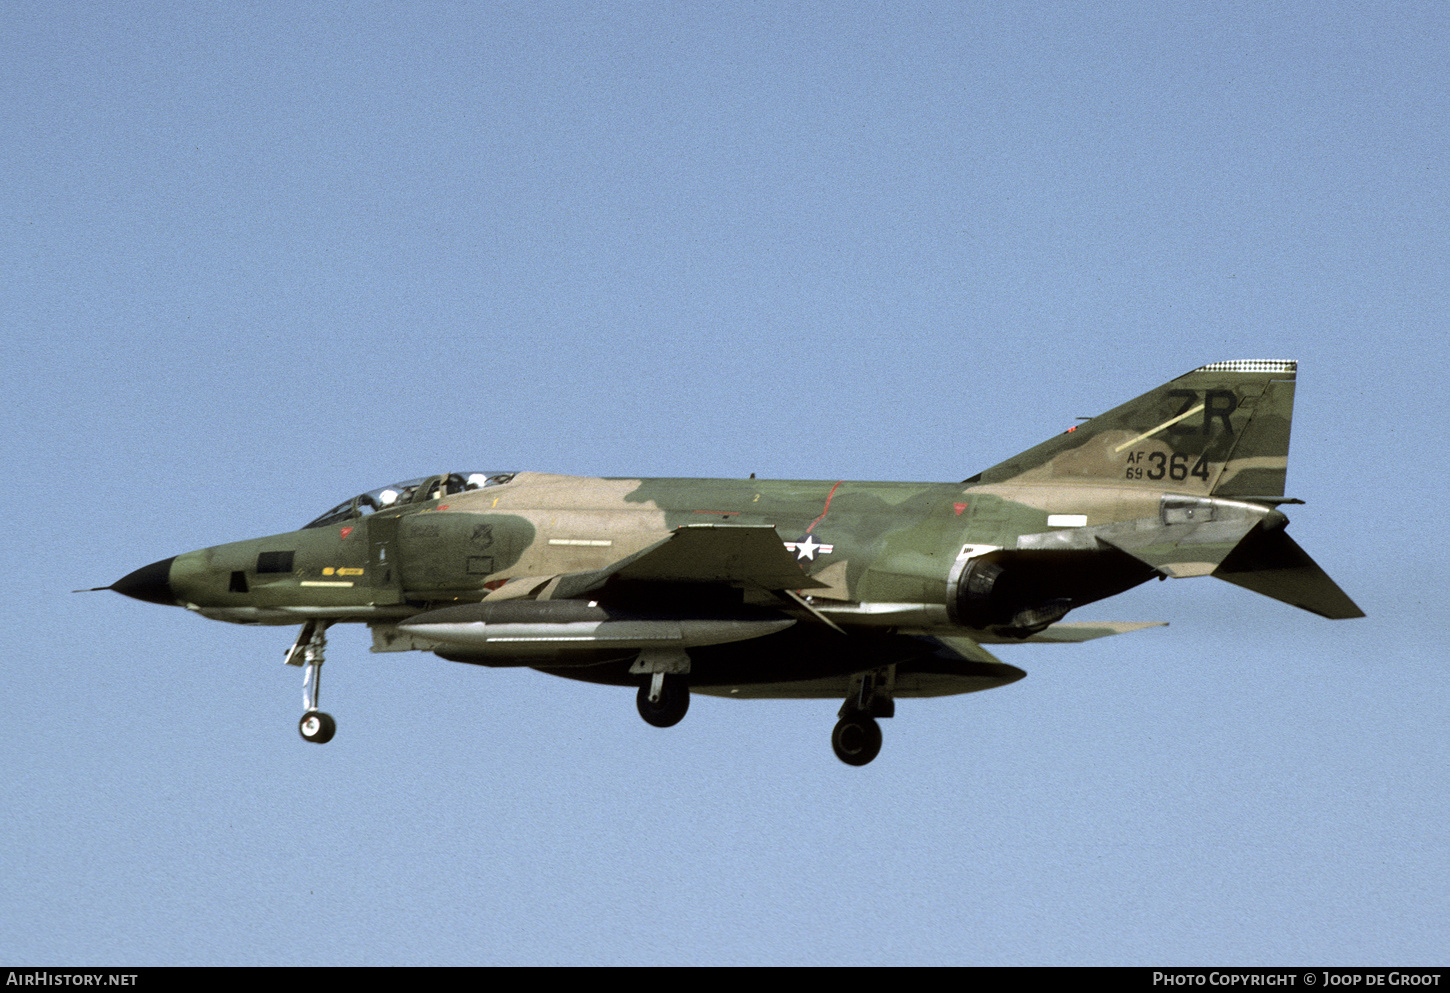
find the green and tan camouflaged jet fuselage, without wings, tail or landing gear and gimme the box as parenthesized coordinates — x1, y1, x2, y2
(117, 463, 1200, 631)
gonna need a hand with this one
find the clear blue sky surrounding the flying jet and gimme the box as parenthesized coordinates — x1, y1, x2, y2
(0, 3, 1450, 964)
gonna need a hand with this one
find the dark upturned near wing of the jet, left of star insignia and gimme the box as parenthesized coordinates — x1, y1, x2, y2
(550, 525, 827, 600)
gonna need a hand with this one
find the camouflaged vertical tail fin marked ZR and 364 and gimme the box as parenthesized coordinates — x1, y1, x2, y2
(967, 360, 1298, 497)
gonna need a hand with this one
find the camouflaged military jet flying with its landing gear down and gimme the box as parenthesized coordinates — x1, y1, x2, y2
(99, 361, 1363, 765)
